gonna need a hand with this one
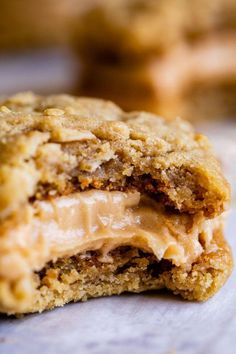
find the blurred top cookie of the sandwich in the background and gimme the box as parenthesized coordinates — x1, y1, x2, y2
(75, 0, 236, 62)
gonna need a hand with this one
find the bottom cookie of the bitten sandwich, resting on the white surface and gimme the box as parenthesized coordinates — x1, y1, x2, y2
(0, 230, 233, 314)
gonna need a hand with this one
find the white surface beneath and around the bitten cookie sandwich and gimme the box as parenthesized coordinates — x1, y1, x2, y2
(0, 52, 236, 354)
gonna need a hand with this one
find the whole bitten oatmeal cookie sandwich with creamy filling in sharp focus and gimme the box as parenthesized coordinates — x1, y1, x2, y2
(0, 93, 232, 314)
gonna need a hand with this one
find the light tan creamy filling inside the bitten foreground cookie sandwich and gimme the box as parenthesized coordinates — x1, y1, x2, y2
(0, 190, 221, 280)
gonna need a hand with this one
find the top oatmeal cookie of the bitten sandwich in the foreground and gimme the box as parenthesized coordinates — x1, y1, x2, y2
(0, 93, 229, 218)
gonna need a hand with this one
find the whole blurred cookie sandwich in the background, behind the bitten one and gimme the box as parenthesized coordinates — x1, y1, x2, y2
(76, 0, 236, 118)
